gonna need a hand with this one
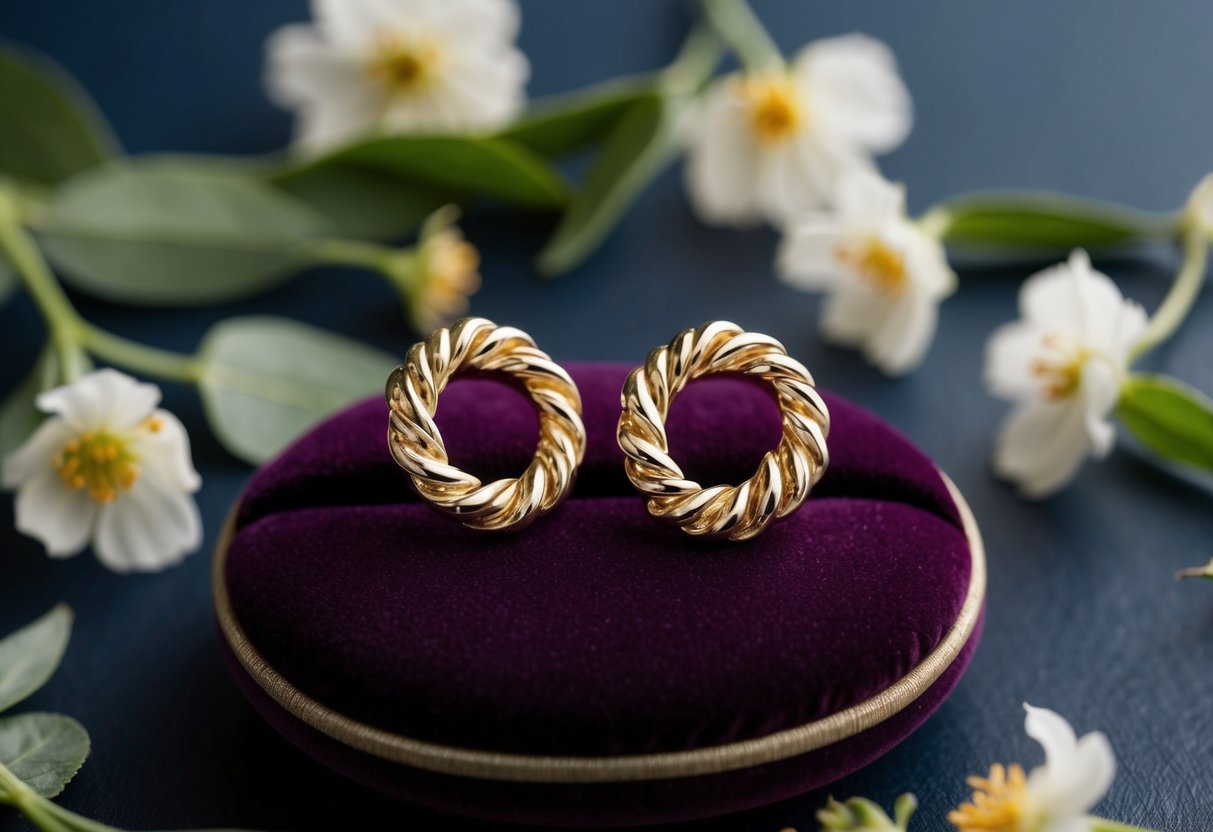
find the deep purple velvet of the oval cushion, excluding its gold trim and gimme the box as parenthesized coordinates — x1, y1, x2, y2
(215, 365, 976, 824)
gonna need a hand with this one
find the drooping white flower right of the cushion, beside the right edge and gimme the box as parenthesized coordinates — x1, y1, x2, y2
(985, 250, 1147, 497)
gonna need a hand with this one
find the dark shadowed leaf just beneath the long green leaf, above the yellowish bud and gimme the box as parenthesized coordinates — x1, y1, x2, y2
(279, 163, 451, 243)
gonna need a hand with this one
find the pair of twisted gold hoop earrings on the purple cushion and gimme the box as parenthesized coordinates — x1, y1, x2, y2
(387, 318, 830, 540)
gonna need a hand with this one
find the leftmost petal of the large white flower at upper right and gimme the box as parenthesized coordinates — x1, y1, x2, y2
(684, 75, 762, 228)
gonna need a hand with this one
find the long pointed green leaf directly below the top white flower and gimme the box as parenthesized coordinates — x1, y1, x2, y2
(277, 136, 568, 211)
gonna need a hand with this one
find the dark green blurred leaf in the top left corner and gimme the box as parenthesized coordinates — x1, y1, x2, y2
(0, 44, 119, 186)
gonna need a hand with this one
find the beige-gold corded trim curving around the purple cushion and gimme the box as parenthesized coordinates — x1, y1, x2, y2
(211, 473, 986, 783)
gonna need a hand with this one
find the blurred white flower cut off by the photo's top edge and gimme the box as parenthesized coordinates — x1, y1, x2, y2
(266, 0, 530, 152)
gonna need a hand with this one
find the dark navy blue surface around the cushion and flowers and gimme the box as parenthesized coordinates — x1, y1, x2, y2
(0, 0, 1213, 832)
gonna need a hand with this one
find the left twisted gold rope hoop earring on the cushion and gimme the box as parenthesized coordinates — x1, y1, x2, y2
(387, 318, 586, 531)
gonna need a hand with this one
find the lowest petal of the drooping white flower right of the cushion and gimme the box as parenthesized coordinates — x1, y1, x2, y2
(993, 399, 1088, 500)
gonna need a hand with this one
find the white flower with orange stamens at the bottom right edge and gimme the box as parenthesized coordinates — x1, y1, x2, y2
(947, 705, 1116, 832)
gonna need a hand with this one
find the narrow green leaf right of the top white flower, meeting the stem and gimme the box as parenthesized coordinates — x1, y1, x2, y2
(499, 79, 653, 156)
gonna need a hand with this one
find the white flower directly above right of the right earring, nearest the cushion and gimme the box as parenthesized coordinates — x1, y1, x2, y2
(776, 170, 956, 375)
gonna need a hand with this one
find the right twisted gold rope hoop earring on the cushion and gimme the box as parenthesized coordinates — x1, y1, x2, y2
(617, 320, 830, 540)
